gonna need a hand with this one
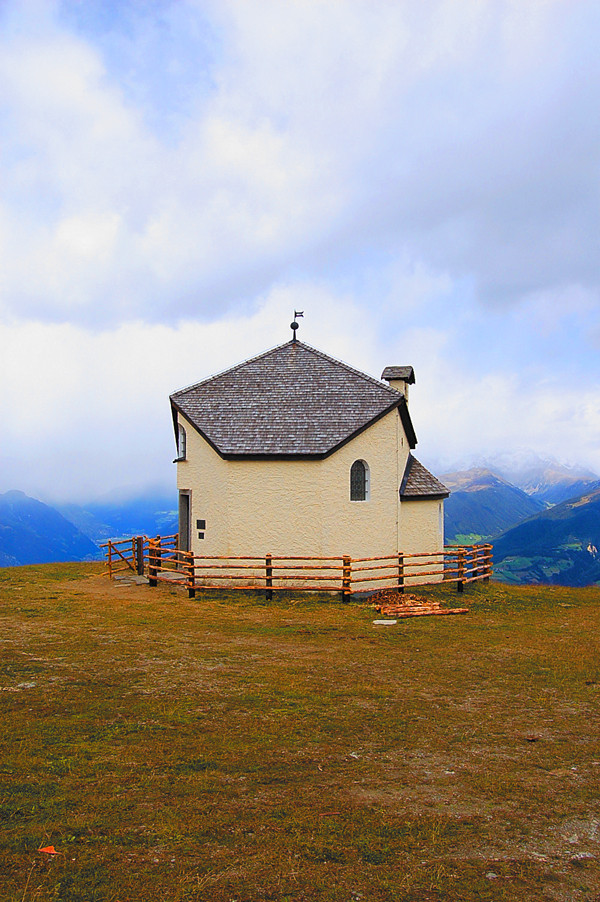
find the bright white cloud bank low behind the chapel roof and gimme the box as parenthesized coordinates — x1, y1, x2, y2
(0, 274, 600, 500)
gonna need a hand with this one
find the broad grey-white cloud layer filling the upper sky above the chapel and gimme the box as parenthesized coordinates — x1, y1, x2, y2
(0, 0, 598, 325)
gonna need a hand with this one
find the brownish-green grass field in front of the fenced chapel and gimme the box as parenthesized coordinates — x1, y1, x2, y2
(0, 564, 600, 902)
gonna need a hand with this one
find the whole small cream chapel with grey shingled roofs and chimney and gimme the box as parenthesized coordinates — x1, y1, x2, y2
(170, 339, 449, 557)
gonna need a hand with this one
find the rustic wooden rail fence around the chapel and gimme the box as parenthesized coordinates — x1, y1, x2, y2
(102, 535, 493, 598)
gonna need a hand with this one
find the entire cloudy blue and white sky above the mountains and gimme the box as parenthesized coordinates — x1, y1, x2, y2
(0, 0, 600, 502)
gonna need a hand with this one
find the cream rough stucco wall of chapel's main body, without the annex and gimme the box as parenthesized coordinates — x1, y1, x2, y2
(177, 410, 409, 557)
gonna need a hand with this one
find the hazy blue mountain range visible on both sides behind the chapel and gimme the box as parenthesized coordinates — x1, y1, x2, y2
(0, 459, 600, 586)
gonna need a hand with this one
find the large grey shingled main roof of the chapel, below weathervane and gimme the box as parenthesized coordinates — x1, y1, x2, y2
(171, 341, 417, 458)
